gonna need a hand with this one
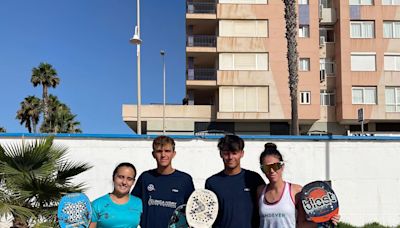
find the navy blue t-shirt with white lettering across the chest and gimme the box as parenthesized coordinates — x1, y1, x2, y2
(131, 169, 194, 228)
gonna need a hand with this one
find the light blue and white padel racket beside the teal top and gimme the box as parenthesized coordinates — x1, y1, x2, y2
(57, 193, 92, 228)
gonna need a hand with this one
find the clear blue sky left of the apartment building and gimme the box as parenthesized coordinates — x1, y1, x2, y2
(0, 0, 185, 134)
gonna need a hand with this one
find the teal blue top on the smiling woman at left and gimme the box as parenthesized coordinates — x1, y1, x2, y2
(92, 194, 143, 228)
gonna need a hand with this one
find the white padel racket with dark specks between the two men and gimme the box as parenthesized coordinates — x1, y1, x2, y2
(186, 189, 218, 228)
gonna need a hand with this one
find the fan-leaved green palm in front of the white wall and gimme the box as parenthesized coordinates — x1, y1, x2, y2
(0, 137, 91, 227)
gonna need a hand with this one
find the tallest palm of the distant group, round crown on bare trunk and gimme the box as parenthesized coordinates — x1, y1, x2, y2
(31, 63, 60, 121)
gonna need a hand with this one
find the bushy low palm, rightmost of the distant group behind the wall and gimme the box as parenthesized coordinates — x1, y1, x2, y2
(40, 94, 82, 133)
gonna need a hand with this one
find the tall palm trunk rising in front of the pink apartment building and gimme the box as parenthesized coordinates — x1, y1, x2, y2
(283, 0, 299, 135)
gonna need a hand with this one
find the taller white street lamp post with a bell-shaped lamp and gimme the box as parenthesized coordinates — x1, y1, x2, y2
(129, 0, 142, 135)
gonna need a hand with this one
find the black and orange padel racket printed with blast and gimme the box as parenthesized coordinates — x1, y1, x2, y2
(300, 181, 339, 227)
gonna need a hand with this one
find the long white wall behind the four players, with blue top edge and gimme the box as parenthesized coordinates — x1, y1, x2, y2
(0, 134, 400, 226)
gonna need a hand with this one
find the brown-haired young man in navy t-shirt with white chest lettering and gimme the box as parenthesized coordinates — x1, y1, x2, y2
(131, 136, 194, 228)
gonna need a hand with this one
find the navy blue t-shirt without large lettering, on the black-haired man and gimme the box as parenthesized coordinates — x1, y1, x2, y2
(205, 169, 265, 228)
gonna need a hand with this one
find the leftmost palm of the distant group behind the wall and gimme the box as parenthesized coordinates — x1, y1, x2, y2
(16, 96, 41, 133)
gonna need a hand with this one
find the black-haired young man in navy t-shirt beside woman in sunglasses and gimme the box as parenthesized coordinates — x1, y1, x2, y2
(205, 135, 265, 228)
